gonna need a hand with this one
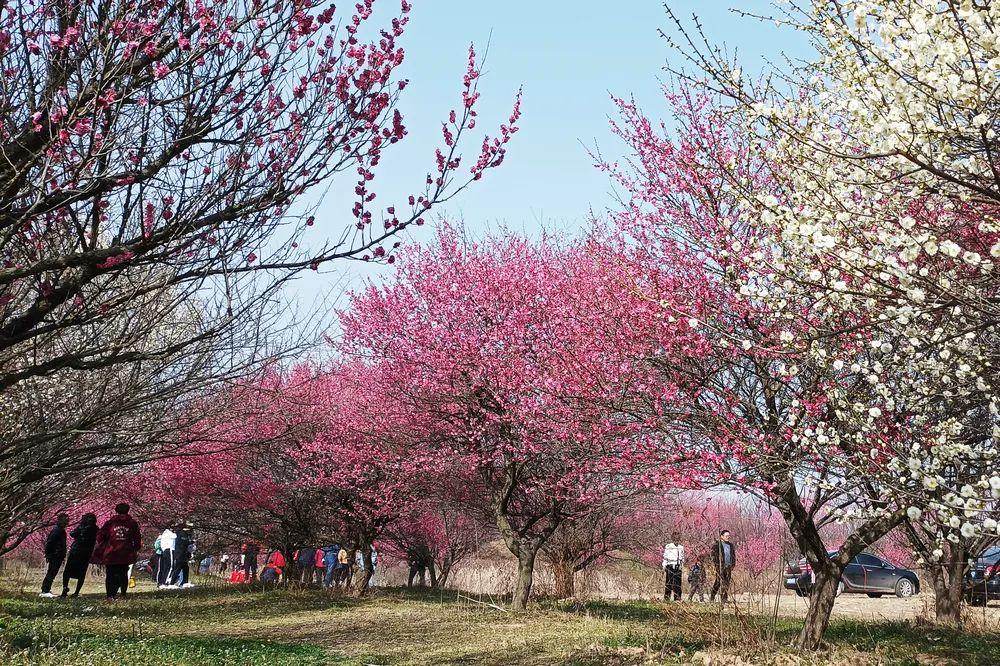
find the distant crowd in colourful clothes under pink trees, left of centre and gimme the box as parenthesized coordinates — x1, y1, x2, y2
(225, 542, 378, 588)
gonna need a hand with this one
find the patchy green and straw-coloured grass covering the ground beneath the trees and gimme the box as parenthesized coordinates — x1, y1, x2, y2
(0, 581, 1000, 666)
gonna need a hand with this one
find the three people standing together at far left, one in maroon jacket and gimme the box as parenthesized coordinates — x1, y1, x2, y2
(39, 503, 142, 601)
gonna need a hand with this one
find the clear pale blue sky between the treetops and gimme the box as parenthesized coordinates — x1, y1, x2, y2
(299, 0, 805, 308)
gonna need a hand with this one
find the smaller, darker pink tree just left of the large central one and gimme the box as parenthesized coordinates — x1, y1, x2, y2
(128, 366, 416, 595)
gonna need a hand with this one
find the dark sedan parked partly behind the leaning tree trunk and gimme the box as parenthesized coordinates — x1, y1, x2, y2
(785, 553, 920, 599)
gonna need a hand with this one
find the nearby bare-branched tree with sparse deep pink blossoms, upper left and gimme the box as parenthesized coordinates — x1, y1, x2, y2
(0, 0, 520, 549)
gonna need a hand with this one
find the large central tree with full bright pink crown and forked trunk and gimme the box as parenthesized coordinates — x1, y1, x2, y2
(342, 228, 698, 609)
